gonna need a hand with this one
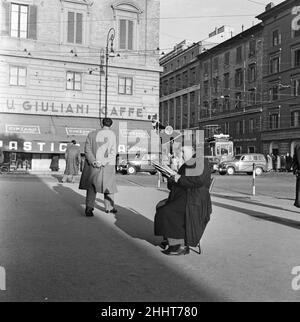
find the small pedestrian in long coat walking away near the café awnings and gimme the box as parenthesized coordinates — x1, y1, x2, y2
(62, 140, 81, 183)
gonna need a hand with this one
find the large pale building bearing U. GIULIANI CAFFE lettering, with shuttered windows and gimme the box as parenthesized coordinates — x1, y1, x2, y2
(0, 0, 160, 170)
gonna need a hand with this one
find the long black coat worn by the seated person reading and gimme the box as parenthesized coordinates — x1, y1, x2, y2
(154, 159, 212, 247)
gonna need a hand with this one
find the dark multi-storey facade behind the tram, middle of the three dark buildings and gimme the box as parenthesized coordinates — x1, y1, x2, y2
(198, 24, 263, 154)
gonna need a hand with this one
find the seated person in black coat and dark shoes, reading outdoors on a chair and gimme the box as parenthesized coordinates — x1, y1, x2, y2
(154, 144, 212, 255)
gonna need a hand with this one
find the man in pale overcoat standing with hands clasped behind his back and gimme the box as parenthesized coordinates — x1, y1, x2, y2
(79, 118, 117, 217)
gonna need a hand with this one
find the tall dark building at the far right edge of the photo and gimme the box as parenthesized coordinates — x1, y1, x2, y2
(257, 0, 300, 155)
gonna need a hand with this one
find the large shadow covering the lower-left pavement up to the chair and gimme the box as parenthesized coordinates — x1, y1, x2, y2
(0, 176, 223, 302)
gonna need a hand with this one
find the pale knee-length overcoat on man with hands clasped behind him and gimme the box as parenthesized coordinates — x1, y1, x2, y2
(79, 129, 117, 193)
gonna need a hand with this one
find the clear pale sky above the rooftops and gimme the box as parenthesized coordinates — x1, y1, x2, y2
(160, 0, 283, 52)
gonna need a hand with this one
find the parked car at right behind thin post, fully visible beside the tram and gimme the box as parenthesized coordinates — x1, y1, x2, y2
(219, 153, 267, 176)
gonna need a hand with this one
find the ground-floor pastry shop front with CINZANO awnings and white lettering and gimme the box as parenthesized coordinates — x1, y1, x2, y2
(0, 113, 156, 171)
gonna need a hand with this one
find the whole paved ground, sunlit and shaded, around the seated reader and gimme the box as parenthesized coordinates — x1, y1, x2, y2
(0, 174, 300, 302)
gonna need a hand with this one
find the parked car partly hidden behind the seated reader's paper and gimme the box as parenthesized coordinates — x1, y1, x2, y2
(117, 153, 159, 175)
